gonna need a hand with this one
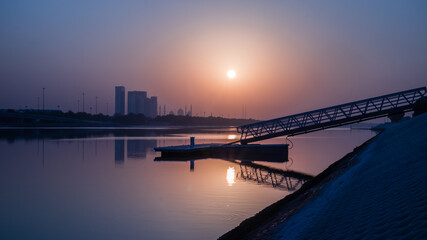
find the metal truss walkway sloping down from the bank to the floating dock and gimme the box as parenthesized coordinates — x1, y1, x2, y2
(236, 87, 426, 144)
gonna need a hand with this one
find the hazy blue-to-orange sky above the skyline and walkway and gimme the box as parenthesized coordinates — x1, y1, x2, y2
(0, 0, 427, 119)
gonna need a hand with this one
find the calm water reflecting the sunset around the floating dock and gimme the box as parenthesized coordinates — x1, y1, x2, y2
(0, 126, 374, 239)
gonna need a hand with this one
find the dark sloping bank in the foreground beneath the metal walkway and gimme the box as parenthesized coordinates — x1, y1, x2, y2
(219, 113, 427, 240)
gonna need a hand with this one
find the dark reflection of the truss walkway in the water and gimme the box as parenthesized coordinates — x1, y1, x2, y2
(232, 161, 313, 191)
